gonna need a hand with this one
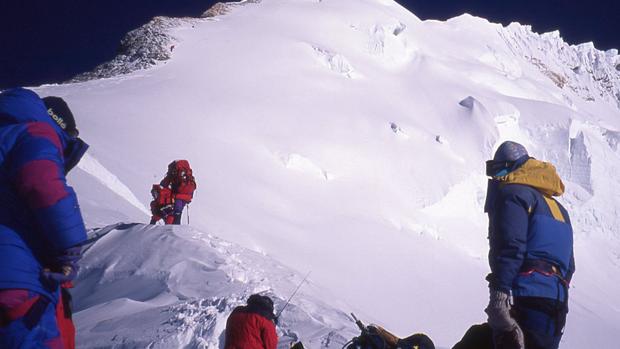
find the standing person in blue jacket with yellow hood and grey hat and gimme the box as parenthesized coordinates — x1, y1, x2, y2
(485, 141, 575, 349)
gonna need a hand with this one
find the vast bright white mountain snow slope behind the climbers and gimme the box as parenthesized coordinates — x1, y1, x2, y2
(31, 0, 620, 348)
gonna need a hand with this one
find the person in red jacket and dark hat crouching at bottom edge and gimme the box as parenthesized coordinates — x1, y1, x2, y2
(224, 294, 278, 349)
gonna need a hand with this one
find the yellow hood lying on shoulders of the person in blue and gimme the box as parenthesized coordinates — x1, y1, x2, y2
(496, 159, 564, 196)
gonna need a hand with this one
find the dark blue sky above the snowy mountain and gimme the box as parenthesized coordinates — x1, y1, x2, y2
(0, 0, 620, 88)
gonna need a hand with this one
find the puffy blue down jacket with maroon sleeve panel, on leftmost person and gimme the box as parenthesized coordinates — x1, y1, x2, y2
(0, 88, 86, 302)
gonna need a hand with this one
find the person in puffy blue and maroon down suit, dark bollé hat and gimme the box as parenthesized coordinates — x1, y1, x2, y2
(0, 88, 88, 349)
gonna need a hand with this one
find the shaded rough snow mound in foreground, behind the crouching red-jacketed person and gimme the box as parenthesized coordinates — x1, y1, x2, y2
(73, 224, 356, 348)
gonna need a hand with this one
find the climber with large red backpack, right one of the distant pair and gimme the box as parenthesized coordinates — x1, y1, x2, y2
(160, 160, 196, 224)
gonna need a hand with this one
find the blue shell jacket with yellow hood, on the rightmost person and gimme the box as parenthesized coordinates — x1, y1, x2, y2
(486, 158, 575, 301)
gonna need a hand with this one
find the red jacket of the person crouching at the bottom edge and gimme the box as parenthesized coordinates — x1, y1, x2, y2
(224, 307, 278, 349)
